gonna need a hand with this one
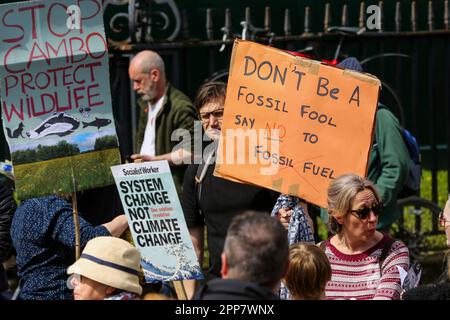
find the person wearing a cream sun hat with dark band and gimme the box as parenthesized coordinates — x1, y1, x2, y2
(67, 237, 142, 300)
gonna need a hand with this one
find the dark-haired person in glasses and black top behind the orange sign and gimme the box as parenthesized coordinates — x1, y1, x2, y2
(181, 82, 278, 295)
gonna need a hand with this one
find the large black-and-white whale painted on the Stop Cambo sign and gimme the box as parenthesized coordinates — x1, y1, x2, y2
(26, 112, 80, 139)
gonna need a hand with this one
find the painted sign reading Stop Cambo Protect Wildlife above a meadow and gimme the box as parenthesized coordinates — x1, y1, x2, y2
(0, 0, 120, 199)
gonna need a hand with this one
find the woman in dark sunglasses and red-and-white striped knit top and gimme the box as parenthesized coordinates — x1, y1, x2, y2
(321, 174, 409, 300)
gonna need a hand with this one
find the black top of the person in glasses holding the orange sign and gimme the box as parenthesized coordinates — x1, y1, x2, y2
(181, 160, 278, 277)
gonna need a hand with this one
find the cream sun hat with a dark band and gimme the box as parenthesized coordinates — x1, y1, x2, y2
(67, 237, 142, 295)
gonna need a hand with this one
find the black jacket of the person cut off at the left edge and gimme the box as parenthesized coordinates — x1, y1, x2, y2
(0, 178, 17, 292)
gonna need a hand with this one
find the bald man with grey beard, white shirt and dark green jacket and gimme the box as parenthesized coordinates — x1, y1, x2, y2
(128, 50, 197, 194)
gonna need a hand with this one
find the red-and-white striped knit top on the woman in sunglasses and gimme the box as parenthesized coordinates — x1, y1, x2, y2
(325, 235, 409, 300)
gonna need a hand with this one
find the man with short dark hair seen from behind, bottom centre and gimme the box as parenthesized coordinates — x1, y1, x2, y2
(194, 211, 289, 300)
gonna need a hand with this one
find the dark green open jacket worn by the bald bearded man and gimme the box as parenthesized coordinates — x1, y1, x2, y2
(135, 84, 197, 195)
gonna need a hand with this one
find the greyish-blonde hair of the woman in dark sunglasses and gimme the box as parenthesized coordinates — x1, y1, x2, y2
(328, 174, 381, 234)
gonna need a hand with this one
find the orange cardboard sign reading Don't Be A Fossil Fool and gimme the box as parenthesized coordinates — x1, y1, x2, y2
(214, 40, 380, 207)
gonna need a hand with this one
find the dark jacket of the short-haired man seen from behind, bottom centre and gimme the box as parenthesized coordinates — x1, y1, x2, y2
(193, 278, 279, 300)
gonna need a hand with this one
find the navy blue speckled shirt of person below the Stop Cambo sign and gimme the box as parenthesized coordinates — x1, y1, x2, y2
(11, 196, 110, 300)
